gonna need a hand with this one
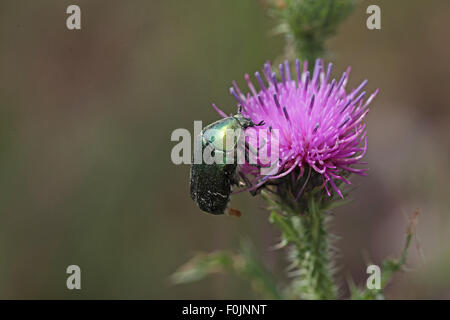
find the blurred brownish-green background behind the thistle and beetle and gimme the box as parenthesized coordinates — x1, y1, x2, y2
(0, 0, 450, 299)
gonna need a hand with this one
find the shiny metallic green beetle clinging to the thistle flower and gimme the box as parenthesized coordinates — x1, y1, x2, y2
(190, 112, 262, 214)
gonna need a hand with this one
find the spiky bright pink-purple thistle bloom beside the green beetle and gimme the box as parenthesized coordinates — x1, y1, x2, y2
(214, 59, 378, 197)
